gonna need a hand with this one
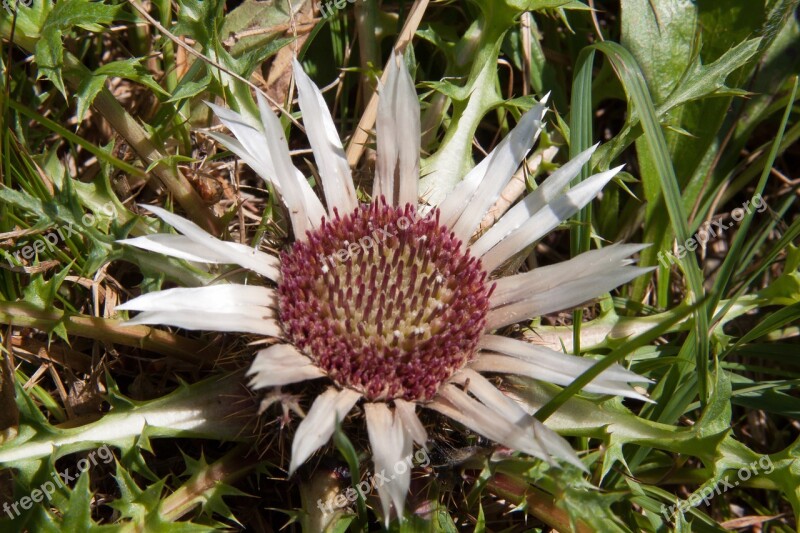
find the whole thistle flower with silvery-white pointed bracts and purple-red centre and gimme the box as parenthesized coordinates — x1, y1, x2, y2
(118, 56, 648, 523)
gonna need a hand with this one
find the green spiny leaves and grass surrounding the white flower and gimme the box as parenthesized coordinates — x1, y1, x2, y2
(0, 0, 800, 532)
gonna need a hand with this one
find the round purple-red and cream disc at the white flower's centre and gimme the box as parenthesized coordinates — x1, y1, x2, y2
(278, 201, 491, 401)
